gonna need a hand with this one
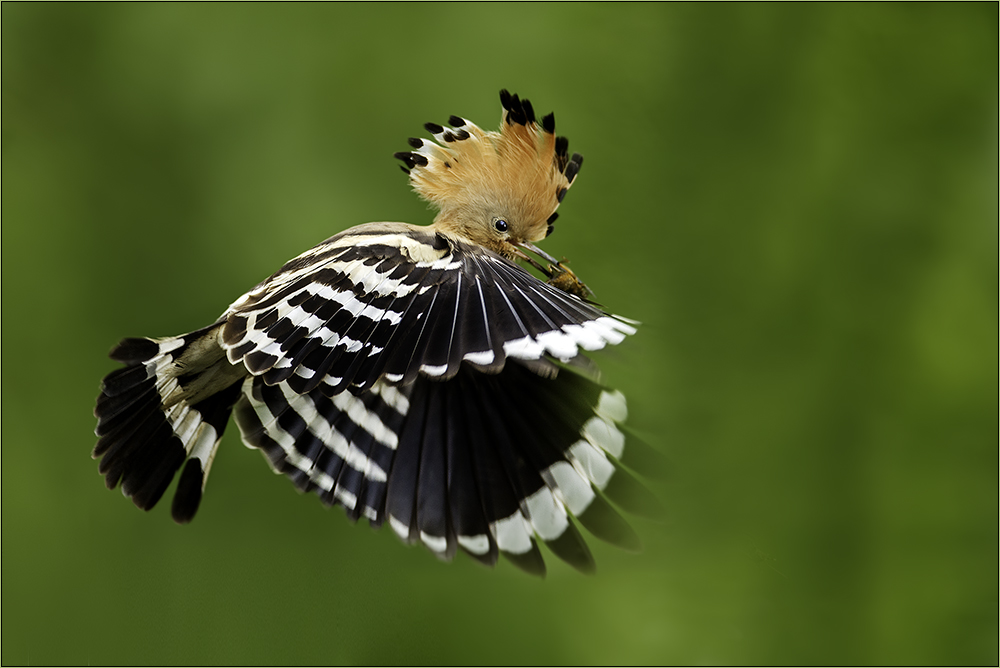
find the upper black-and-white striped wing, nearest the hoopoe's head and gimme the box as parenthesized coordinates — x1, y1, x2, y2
(222, 223, 635, 396)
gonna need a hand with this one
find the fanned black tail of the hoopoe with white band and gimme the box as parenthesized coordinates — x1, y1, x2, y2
(92, 324, 246, 523)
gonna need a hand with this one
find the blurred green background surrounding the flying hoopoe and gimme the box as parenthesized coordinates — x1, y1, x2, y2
(0, 3, 998, 665)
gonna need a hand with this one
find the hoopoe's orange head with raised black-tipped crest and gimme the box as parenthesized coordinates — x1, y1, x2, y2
(396, 90, 583, 258)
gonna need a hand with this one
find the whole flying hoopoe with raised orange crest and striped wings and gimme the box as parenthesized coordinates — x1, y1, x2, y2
(93, 91, 641, 574)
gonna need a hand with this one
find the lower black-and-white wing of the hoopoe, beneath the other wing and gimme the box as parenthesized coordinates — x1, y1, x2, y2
(230, 362, 655, 573)
